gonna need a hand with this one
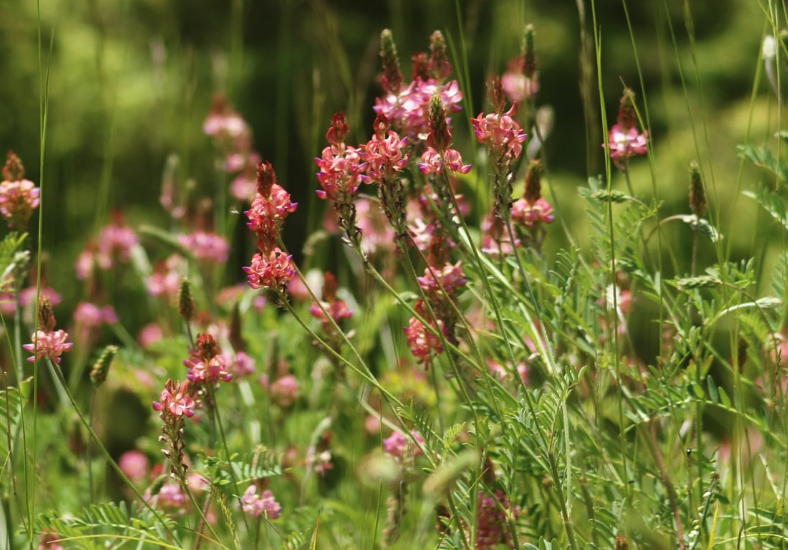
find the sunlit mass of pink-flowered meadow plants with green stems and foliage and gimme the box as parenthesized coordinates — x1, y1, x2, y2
(0, 3, 788, 550)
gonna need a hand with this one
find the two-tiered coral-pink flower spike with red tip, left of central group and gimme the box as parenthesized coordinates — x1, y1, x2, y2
(244, 161, 297, 292)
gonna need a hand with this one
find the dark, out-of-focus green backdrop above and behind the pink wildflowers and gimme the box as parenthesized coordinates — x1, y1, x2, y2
(0, 0, 782, 322)
